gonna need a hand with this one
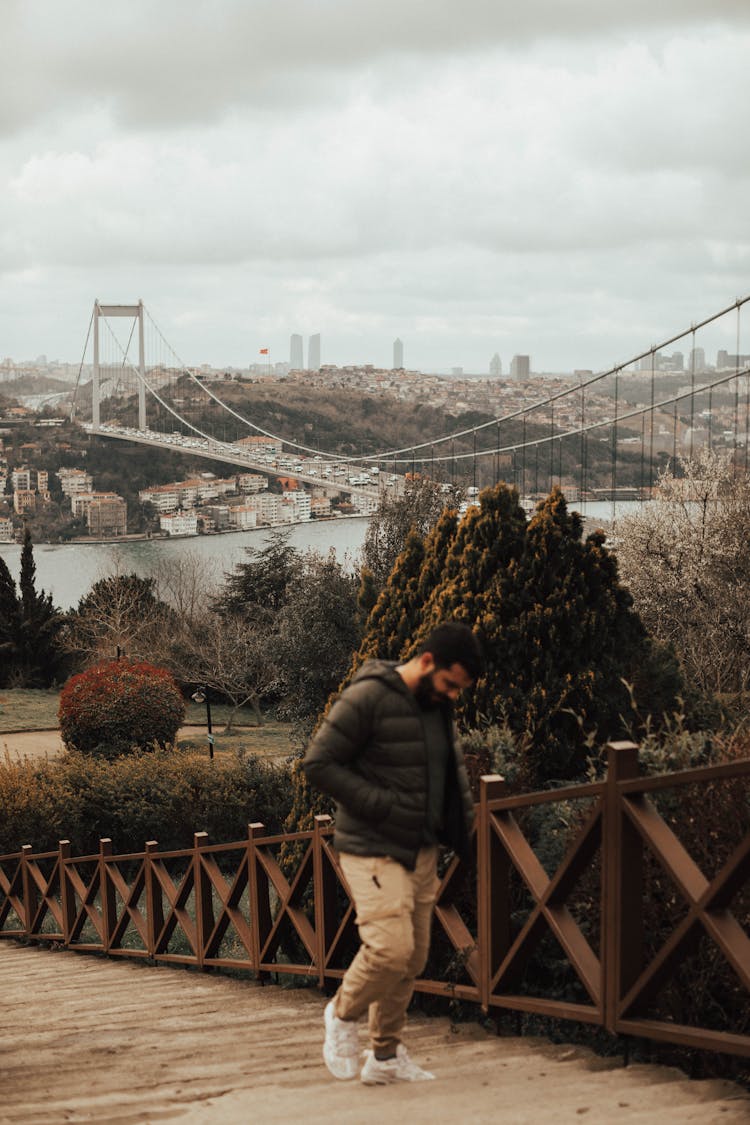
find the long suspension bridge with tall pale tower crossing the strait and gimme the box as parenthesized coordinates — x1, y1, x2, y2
(72, 297, 750, 516)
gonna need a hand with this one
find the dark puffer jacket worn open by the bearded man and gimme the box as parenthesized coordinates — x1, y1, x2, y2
(302, 660, 473, 870)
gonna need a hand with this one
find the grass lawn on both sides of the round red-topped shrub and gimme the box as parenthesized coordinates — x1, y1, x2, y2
(0, 689, 292, 757)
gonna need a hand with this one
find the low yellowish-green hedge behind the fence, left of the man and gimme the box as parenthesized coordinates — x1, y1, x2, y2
(0, 749, 290, 855)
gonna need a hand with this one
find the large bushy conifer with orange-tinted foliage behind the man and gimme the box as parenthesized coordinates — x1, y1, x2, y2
(354, 485, 681, 784)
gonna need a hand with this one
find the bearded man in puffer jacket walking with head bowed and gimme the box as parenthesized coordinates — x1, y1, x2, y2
(302, 622, 481, 1086)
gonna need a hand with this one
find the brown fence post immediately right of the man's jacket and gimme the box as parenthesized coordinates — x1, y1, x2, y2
(477, 774, 508, 1011)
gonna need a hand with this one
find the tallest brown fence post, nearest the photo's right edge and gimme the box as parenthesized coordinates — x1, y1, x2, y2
(602, 743, 643, 1034)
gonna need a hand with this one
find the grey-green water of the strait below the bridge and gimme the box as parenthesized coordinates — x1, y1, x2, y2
(0, 501, 641, 610)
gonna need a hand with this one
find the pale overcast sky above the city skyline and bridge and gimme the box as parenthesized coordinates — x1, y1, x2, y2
(0, 0, 750, 372)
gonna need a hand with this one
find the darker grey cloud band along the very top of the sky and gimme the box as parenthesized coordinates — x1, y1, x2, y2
(0, 0, 750, 132)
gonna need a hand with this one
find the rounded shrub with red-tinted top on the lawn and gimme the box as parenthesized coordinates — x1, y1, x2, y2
(58, 660, 184, 758)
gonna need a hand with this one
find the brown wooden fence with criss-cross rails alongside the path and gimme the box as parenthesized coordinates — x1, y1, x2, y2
(0, 743, 750, 1056)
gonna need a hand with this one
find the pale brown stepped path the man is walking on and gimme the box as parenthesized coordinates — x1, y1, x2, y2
(0, 942, 750, 1125)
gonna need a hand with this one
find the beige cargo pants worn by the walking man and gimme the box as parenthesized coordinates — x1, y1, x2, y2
(334, 847, 439, 1058)
